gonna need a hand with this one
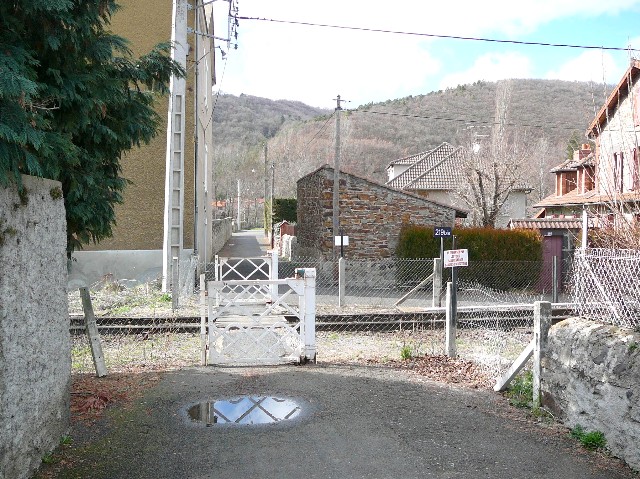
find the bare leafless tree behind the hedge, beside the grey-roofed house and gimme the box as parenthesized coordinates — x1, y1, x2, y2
(457, 81, 533, 228)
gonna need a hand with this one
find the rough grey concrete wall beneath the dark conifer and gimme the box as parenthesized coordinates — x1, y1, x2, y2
(0, 177, 71, 479)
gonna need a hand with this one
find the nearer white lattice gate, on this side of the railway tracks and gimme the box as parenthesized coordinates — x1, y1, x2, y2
(207, 268, 316, 365)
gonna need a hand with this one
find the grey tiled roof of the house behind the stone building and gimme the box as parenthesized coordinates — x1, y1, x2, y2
(387, 143, 462, 190)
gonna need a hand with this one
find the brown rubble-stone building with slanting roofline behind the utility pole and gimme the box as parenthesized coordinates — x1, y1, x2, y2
(296, 165, 466, 259)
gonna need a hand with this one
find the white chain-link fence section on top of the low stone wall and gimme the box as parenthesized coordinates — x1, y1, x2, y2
(571, 248, 640, 328)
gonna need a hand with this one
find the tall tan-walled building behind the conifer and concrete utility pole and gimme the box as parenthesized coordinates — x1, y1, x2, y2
(71, 0, 215, 284)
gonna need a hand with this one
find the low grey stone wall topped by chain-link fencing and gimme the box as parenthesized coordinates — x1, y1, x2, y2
(542, 318, 640, 469)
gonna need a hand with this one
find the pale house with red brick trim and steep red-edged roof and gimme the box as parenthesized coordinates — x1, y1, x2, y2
(511, 60, 640, 288)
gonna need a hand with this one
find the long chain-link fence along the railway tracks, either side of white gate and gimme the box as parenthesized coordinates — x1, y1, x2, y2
(69, 258, 550, 380)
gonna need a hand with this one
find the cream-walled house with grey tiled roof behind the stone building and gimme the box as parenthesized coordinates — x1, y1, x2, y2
(387, 142, 529, 228)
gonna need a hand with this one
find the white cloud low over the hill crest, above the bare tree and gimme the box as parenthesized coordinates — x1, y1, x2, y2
(440, 53, 531, 89)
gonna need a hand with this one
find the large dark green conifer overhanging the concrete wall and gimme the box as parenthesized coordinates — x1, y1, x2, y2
(0, 0, 185, 252)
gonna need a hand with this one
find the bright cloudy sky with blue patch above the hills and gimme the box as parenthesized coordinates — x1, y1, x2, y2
(214, 0, 640, 108)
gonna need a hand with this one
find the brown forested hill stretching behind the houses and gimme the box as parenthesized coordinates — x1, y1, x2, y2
(214, 80, 605, 200)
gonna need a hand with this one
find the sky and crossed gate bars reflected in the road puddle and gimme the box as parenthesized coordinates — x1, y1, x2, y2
(187, 396, 301, 426)
